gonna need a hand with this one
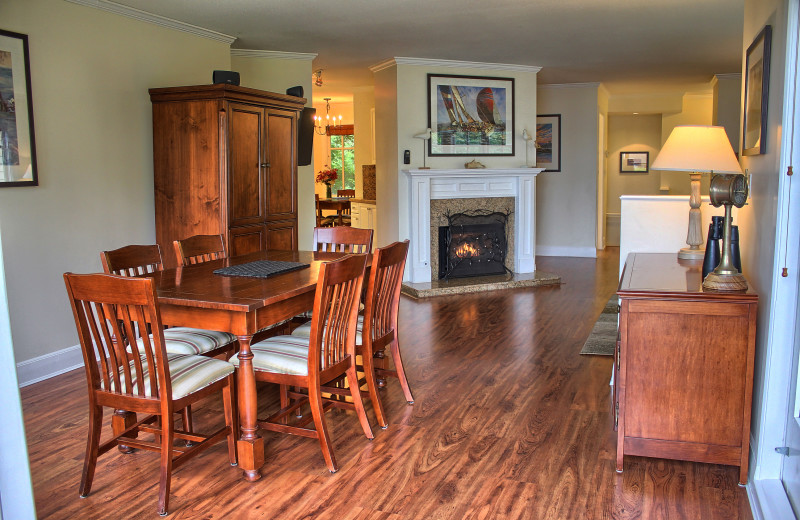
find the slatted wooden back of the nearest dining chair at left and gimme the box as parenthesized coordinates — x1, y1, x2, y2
(64, 273, 172, 399)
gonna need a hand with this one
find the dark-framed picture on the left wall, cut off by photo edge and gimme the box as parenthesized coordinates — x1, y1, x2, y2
(0, 29, 39, 187)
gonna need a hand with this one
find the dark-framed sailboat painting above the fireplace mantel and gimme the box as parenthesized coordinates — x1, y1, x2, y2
(428, 74, 514, 156)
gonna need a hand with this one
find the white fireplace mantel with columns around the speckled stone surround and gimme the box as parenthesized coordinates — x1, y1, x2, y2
(403, 168, 544, 283)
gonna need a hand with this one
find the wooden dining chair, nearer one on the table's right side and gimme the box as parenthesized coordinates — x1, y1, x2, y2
(230, 255, 373, 473)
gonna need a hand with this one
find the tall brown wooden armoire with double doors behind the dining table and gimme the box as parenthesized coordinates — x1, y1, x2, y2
(150, 84, 305, 267)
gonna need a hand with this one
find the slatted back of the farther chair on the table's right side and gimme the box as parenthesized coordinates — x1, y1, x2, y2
(362, 240, 408, 351)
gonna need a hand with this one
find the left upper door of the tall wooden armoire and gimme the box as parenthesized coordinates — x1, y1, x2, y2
(228, 103, 266, 227)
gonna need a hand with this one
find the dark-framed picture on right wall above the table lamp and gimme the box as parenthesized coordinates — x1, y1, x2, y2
(742, 25, 772, 155)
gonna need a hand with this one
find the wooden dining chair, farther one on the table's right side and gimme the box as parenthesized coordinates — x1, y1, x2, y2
(292, 240, 414, 428)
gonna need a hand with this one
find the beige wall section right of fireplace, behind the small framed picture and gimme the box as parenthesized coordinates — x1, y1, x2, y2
(536, 84, 600, 256)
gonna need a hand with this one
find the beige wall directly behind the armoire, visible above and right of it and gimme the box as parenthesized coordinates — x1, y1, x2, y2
(231, 56, 316, 249)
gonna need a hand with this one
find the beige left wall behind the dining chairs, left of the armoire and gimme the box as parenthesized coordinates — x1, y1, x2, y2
(0, 0, 230, 362)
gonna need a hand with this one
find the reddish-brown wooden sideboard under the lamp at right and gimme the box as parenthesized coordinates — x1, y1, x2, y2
(614, 253, 758, 484)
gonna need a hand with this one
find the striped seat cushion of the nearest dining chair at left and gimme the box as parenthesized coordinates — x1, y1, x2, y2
(101, 354, 233, 399)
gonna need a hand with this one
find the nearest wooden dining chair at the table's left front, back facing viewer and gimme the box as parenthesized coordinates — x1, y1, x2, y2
(64, 273, 238, 516)
